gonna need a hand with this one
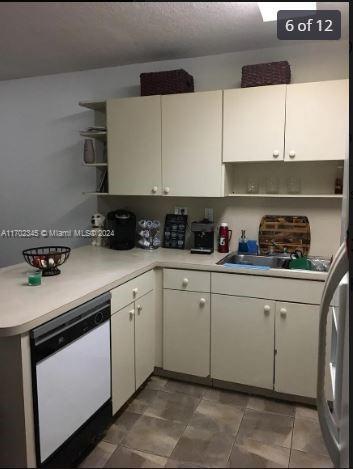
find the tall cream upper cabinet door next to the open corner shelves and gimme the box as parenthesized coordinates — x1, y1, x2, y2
(107, 96, 162, 195)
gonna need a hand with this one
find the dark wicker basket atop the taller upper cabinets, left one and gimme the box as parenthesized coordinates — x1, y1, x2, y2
(140, 69, 194, 96)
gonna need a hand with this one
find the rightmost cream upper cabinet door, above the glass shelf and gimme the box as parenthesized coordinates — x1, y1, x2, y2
(285, 80, 349, 161)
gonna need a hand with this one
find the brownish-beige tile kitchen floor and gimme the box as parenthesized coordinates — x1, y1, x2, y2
(79, 376, 333, 468)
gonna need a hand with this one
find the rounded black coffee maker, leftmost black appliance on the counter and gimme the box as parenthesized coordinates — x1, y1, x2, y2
(107, 210, 136, 250)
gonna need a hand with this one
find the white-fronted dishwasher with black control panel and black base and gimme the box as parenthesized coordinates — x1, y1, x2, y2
(31, 293, 112, 467)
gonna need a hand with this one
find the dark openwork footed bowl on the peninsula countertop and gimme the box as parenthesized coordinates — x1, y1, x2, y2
(22, 246, 71, 277)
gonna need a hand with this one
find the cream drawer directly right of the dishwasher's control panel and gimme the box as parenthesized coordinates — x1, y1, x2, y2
(110, 270, 154, 314)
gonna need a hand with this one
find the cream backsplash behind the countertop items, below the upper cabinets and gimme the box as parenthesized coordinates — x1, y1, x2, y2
(98, 196, 341, 257)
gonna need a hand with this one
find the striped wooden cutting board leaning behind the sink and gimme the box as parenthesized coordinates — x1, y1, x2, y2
(259, 215, 310, 256)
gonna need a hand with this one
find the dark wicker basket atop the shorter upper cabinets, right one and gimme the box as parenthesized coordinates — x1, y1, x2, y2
(241, 60, 291, 88)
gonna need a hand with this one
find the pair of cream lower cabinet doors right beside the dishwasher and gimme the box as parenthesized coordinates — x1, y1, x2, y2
(111, 291, 155, 414)
